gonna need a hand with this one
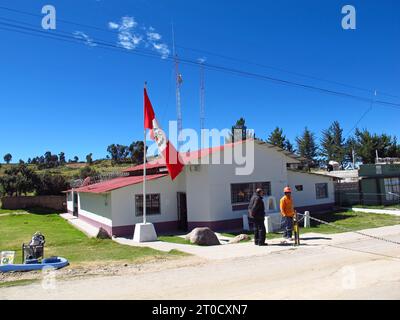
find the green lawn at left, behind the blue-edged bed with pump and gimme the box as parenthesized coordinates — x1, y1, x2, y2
(0, 213, 188, 264)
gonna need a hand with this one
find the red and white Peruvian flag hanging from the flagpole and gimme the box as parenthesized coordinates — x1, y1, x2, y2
(144, 88, 184, 180)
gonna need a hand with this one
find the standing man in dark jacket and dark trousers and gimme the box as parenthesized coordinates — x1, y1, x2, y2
(249, 188, 266, 246)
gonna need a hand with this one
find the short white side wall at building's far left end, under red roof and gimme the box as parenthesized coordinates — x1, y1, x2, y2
(78, 192, 112, 226)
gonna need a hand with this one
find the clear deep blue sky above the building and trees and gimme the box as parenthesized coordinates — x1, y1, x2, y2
(0, 0, 400, 161)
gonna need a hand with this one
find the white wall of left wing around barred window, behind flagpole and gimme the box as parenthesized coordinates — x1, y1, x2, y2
(111, 174, 185, 227)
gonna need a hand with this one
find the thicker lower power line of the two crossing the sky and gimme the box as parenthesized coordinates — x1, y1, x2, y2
(0, 17, 400, 110)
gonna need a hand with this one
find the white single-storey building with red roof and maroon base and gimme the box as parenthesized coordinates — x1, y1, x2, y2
(67, 141, 334, 236)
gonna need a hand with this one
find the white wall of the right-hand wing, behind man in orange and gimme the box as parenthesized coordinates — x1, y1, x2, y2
(288, 170, 335, 207)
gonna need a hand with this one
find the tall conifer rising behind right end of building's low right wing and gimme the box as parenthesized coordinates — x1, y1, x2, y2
(320, 121, 346, 165)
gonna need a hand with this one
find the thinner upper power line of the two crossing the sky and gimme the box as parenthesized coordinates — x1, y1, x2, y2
(0, 6, 400, 100)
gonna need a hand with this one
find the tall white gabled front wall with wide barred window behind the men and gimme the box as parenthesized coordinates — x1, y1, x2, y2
(187, 144, 289, 221)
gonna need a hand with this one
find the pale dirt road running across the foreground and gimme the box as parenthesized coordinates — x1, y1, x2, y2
(0, 227, 400, 299)
